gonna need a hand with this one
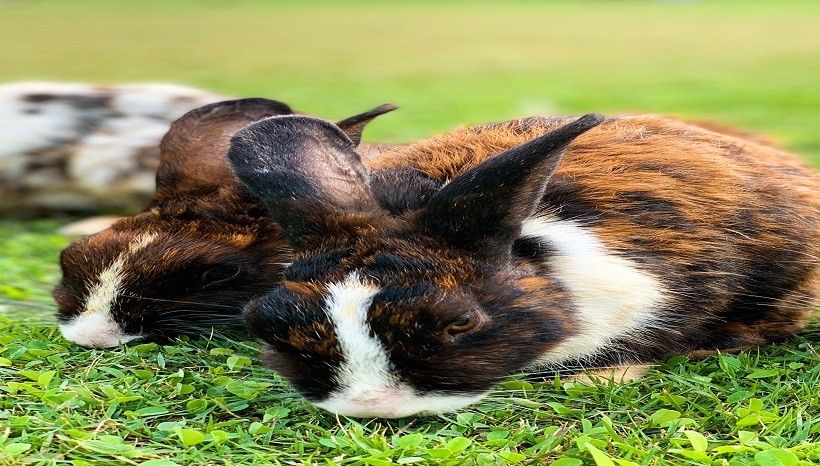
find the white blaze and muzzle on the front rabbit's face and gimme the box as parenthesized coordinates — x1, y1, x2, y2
(316, 273, 484, 418)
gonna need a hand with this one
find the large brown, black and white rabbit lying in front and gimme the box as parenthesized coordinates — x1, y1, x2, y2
(228, 114, 820, 418)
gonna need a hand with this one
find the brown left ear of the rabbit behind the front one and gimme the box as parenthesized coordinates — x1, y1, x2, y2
(153, 98, 293, 202)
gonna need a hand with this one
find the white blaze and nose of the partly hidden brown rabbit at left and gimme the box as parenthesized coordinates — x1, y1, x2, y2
(60, 233, 157, 348)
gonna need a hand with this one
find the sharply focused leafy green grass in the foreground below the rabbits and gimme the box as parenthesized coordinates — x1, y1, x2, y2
(0, 306, 820, 466)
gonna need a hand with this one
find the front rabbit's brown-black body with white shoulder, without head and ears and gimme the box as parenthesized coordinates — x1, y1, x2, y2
(370, 116, 820, 364)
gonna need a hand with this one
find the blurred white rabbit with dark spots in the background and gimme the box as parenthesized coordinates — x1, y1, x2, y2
(0, 82, 225, 217)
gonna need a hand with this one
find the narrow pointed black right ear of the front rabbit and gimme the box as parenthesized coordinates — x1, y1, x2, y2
(419, 114, 604, 254)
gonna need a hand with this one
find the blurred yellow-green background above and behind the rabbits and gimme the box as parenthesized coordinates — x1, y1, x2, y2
(0, 0, 820, 166)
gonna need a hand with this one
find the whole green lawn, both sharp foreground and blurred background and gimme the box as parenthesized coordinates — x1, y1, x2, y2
(0, 0, 820, 466)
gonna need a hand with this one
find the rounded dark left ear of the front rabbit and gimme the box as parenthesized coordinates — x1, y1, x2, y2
(228, 116, 380, 246)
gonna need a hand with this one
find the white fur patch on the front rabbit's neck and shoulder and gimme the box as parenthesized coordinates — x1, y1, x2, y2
(521, 216, 666, 365)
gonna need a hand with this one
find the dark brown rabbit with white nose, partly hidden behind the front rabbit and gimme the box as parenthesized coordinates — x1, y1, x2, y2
(53, 98, 396, 347)
